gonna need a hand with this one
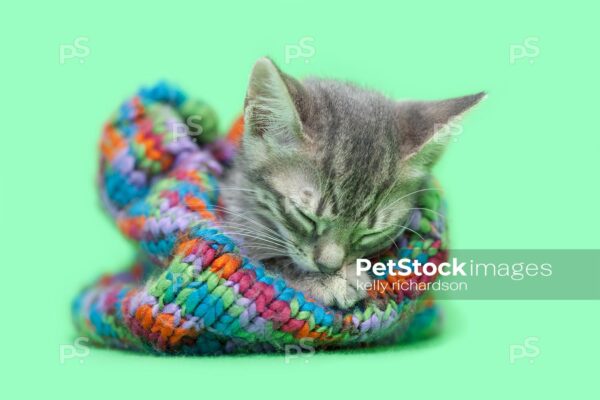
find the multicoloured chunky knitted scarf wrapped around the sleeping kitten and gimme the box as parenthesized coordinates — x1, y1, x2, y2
(72, 83, 447, 354)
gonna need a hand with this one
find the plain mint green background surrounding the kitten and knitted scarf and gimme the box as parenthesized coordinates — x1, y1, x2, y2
(0, 1, 600, 399)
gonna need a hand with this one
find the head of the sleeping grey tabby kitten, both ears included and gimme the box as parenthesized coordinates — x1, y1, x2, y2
(241, 58, 484, 273)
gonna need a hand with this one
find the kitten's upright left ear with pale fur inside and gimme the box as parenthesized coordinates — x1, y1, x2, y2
(244, 57, 304, 146)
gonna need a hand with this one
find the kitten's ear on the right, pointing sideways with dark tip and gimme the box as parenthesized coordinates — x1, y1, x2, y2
(397, 92, 486, 163)
